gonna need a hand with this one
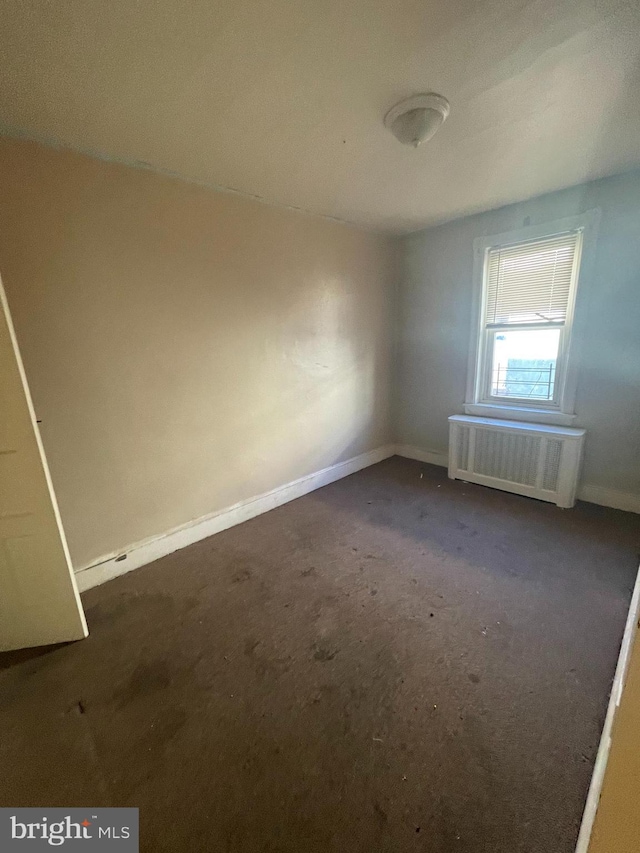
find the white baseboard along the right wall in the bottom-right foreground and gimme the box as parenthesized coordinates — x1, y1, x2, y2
(575, 569, 640, 853)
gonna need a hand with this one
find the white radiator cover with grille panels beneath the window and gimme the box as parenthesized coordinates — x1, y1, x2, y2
(449, 415, 585, 507)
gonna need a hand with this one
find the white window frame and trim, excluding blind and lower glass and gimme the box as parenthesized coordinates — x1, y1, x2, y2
(464, 210, 600, 426)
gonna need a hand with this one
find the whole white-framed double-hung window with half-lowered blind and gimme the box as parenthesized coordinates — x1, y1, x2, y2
(465, 214, 593, 423)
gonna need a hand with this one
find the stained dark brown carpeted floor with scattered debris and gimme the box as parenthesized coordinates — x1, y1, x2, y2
(0, 458, 639, 853)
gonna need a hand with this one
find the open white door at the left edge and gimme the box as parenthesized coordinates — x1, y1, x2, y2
(0, 281, 89, 651)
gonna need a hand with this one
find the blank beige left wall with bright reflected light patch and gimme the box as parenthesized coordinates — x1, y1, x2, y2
(0, 139, 394, 567)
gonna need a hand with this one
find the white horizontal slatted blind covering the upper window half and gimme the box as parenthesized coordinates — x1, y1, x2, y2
(485, 231, 580, 327)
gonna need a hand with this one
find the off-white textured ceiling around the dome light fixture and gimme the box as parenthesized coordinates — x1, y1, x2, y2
(0, 0, 640, 233)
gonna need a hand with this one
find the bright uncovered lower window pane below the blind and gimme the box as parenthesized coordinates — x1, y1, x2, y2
(490, 329, 560, 400)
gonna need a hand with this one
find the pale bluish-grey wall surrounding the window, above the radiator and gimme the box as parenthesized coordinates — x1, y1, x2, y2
(396, 171, 640, 495)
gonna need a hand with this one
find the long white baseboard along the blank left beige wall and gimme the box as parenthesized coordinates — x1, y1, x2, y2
(76, 445, 395, 592)
